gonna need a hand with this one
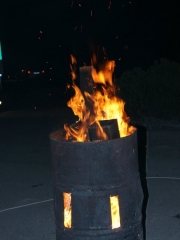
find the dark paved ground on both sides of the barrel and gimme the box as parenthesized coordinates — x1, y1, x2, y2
(0, 110, 180, 240)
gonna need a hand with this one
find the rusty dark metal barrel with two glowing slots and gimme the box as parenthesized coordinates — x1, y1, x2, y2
(50, 130, 143, 240)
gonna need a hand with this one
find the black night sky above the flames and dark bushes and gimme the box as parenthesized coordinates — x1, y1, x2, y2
(0, 0, 180, 78)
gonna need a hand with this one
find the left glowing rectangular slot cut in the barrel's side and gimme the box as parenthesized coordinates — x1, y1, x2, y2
(63, 192, 72, 228)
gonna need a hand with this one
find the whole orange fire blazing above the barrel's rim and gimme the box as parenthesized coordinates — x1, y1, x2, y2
(64, 55, 134, 142)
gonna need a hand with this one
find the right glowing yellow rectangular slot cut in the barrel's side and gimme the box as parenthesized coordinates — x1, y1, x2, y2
(110, 195, 121, 229)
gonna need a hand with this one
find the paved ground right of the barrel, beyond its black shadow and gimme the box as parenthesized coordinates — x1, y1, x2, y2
(146, 130, 180, 240)
